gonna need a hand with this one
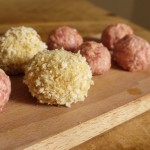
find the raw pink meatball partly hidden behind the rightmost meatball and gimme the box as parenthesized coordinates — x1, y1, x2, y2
(101, 23, 133, 50)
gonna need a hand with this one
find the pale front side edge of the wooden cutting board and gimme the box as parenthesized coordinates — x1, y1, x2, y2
(25, 94, 150, 150)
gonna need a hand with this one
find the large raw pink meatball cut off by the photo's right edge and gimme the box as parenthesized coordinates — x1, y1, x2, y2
(113, 35, 150, 71)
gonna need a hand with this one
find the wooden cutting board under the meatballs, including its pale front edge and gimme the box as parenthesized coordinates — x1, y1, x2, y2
(0, 47, 150, 150)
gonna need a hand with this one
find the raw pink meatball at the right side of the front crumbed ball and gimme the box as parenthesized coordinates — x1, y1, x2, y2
(79, 41, 111, 75)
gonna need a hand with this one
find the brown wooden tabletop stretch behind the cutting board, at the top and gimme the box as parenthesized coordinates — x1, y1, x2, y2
(0, 0, 109, 24)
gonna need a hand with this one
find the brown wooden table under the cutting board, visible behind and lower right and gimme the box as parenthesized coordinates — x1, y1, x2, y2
(0, 0, 150, 150)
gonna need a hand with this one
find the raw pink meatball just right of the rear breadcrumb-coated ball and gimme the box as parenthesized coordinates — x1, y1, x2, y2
(48, 26, 83, 52)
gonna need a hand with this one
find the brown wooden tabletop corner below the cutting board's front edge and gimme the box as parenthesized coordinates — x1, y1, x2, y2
(71, 111, 150, 150)
